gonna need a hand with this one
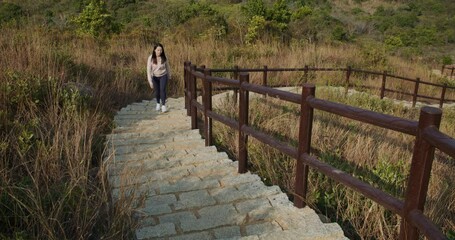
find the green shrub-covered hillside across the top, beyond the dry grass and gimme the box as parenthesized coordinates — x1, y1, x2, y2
(0, 0, 455, 65)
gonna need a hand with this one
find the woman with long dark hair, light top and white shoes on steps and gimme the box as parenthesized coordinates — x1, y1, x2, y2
(147, 43, 171, 112)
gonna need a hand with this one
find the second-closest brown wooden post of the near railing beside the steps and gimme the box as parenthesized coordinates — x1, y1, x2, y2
(294, 83, 316, 208)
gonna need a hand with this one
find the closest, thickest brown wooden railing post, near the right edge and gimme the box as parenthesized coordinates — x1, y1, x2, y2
(400, 107, 442, 240)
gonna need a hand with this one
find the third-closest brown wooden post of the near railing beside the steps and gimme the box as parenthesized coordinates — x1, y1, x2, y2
(238, 73, 250, 173)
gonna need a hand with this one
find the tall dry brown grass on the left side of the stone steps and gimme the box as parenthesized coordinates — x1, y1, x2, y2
(0, 28, 147, 239)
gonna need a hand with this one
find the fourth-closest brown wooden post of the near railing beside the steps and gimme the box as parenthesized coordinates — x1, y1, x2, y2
(203, 68, 212, 146)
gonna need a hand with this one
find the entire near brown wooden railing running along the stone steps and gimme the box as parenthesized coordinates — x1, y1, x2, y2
(184, 62, 455, 240)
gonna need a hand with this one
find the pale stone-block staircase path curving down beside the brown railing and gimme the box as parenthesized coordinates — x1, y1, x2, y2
(105, 98, 347, 240)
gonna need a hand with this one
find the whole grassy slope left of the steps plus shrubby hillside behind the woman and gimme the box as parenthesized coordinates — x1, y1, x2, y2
(0, 0, 455, 239)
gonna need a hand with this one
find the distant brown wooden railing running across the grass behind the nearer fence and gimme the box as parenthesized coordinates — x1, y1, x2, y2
(203, 66, 455, 108)
